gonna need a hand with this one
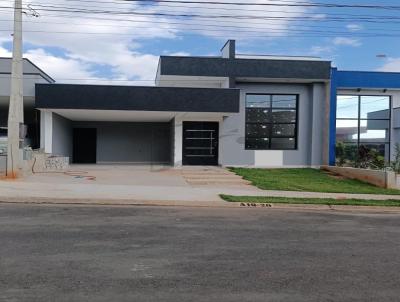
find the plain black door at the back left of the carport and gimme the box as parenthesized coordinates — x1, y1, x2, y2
(72, 128, 97, 164)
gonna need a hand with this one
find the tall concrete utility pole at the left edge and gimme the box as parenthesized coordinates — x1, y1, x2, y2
(7, 0, 24, 178)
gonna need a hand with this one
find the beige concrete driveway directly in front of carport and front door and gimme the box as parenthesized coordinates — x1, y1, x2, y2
(24, 165, 252, 187)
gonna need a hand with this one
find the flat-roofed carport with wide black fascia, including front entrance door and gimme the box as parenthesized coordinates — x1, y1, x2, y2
(36, 84, 239, 165)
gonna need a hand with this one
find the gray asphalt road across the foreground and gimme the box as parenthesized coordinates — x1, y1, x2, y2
(0, 204, 400, 302)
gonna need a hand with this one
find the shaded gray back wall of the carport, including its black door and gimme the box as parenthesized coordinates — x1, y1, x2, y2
(73, 122, 171, 164)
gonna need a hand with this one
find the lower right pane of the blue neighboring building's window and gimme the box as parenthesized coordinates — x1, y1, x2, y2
(360, 120, 389, 142)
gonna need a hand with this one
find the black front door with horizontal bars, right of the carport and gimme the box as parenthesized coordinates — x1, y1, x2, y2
(182, 122, 219, 166)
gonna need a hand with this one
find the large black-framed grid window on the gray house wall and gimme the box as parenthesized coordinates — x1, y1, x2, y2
(246, 94, 298, 150)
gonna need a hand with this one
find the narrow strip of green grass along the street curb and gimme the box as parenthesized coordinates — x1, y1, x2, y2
(220, 194, 400, 207)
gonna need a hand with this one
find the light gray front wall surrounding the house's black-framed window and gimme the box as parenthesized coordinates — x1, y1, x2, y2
(220, 83, 324, 166)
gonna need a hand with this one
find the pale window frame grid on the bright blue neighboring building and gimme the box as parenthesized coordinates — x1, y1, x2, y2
(335, 94, 394, 159)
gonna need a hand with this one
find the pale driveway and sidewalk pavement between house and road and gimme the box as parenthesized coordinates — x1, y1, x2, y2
(0, 166, 400, 206)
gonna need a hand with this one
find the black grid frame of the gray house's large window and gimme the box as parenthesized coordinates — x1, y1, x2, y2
(244, 93, 300, 151)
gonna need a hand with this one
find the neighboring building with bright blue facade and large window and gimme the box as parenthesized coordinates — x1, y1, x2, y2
(330, 68, 400, 165)
